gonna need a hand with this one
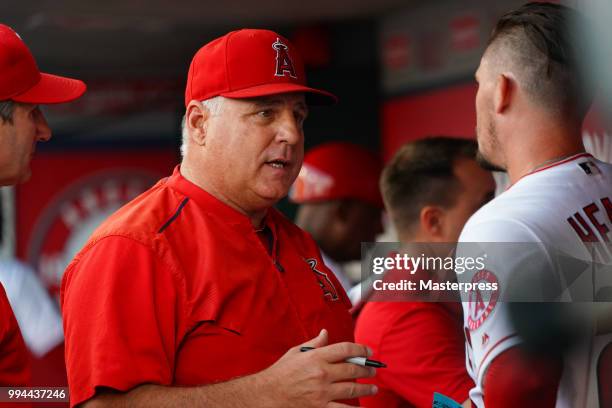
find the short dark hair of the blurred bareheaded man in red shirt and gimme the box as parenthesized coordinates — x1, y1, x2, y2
(380, 136, 478, 230)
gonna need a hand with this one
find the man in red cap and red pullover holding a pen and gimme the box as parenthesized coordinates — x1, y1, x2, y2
(61, 29, 376, 408)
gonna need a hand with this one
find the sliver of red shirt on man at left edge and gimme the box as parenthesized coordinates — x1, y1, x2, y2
(0, 284, 31, 387)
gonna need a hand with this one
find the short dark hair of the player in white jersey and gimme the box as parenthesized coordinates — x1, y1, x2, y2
(488, 2, 593, 119)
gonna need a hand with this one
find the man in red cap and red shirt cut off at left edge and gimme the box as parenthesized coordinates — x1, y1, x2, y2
(0, 24, 86, 386)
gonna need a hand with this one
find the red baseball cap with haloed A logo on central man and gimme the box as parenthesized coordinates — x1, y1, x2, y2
(185, 29, 337, 106)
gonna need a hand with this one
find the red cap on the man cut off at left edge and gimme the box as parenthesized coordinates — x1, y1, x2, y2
(0, 24, 87, 104)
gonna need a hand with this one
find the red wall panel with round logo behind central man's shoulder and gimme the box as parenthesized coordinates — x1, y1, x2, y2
(13, 148, 176, 298)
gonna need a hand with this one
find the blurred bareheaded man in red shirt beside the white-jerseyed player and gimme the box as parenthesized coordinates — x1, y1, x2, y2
(355, 137, 495, 408)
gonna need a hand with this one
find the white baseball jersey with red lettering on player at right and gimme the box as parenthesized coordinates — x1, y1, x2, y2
(457, 153, 612, 408)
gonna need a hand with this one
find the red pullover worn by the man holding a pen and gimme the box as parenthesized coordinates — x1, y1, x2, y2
(61, 168, 353, 405)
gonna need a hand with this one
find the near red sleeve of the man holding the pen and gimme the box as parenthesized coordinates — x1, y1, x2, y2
(61, 236, 186, 406)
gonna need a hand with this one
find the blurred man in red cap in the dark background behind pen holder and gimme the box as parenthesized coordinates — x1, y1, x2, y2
(289, 142, 383, 292)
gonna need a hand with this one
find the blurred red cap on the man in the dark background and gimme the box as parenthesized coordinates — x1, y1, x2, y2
(289, 142, 384, 208)
